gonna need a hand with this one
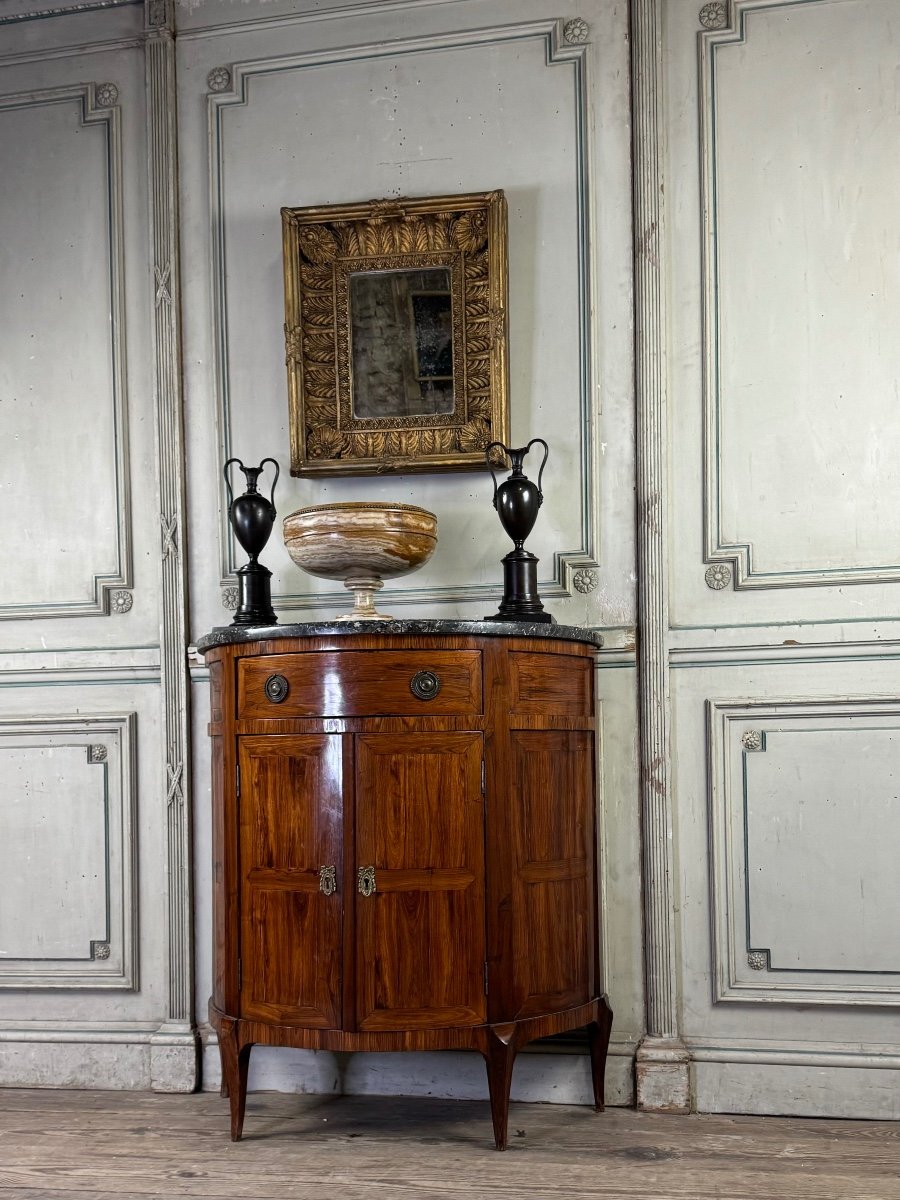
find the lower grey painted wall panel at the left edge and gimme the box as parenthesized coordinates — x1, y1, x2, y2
(0, 676, 167, 1022)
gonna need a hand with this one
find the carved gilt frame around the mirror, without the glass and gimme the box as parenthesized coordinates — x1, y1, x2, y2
(281, 191, 509, 475)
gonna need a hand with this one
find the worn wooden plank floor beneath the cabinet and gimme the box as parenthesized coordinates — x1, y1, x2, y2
(0, 1090, 900, 1200)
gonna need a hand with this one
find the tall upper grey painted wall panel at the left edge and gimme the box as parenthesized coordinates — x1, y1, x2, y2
(0, 39, 160, 650)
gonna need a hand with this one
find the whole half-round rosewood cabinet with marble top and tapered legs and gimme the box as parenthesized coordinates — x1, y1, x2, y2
(198, 620, 612, 1150)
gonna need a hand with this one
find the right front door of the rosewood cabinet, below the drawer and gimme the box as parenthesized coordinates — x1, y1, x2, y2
(356, 733, 485, 1030)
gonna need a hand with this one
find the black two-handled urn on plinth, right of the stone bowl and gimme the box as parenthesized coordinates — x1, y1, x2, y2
(485, 438, 556, 625)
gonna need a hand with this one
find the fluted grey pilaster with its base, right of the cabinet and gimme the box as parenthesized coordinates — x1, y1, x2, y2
(631, 0, 688, 1109)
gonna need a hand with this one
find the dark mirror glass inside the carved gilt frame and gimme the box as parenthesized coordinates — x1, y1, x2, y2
(349, 268, 455, 419)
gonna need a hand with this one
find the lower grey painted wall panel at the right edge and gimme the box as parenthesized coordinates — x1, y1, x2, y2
(672, 653, 900, 1051)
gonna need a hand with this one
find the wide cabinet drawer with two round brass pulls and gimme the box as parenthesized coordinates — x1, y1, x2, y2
(238, 650, 481, 720)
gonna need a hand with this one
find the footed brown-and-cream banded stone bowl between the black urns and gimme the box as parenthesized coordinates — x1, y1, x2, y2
(284, 503, 438, 620)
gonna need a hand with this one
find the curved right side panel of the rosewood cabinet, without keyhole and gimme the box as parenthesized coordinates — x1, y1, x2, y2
(511, 731, 594, 1018)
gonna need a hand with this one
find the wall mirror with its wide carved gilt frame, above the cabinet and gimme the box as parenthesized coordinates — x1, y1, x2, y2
(282, 192, 509, 475)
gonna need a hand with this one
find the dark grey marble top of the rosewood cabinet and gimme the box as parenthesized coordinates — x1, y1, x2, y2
(197, 620, 604, 654)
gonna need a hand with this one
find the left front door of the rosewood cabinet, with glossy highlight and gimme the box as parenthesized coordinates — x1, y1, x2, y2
(239, 734, 343, 1028)
